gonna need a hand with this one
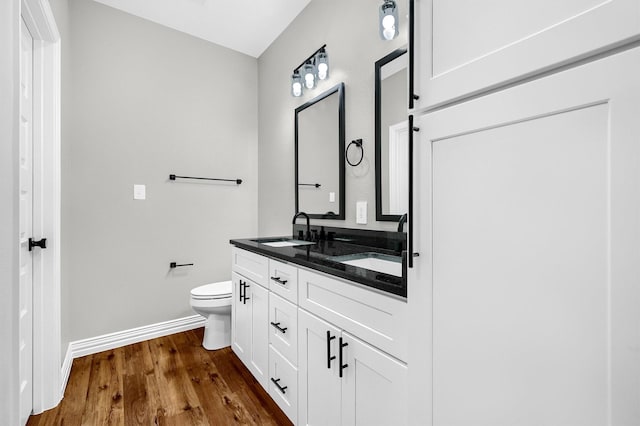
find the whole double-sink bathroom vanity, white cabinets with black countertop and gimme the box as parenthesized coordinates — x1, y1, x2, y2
(231, 226, 408, 425)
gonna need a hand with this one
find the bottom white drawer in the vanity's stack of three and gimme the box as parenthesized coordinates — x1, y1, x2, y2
(268, 347, 298, 424)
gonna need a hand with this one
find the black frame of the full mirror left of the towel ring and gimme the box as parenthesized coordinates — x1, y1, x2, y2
(294, 83, 345, 220)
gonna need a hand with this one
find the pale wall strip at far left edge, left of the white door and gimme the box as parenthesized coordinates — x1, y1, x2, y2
(0, 0, 20, 424)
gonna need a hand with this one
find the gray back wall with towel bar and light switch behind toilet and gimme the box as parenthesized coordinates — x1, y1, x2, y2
(57, 0, 258, 348)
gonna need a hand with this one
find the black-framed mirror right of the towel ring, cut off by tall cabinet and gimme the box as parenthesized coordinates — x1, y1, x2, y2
(375, 49, 409, 221)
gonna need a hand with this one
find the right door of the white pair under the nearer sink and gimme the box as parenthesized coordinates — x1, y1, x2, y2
(338, 332, 408, 426)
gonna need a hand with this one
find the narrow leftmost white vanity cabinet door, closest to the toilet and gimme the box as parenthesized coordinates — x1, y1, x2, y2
(231, 272, 251, 365)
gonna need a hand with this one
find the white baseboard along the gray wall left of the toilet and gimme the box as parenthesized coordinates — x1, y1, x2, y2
(61, 315, 205, 395)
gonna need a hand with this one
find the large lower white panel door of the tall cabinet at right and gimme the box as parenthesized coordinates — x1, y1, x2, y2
(408, 47, 640, 426)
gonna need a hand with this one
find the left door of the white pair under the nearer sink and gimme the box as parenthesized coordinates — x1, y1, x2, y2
(298, 309, 341, 426)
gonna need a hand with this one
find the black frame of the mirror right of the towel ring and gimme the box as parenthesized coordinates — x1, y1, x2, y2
(374, 48, 407, 222)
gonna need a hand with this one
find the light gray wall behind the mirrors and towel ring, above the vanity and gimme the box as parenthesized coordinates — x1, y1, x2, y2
(258, 0, 407, 236)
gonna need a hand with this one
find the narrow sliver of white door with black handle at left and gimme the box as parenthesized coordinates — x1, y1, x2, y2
(19, 17, 33, 424)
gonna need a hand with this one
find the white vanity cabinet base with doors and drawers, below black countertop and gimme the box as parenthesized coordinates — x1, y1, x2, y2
(232, 247, 408, 426)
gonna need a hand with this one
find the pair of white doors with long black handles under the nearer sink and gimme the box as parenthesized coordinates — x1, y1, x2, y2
(298, 309, 407, 426)
